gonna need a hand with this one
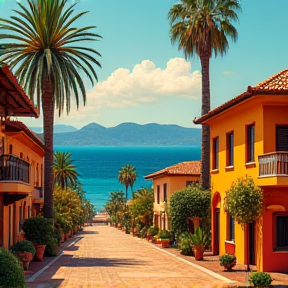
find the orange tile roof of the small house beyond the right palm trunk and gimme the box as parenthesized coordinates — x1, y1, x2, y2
(144, 161, 201, 179)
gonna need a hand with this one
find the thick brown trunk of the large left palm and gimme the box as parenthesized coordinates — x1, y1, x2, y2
(42, 79, 54, 218)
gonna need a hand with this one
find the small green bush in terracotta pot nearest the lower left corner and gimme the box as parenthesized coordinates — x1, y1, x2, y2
(11, 240, 36, 270)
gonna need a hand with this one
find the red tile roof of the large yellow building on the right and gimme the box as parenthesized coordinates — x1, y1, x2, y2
(193, 69, 288, 124)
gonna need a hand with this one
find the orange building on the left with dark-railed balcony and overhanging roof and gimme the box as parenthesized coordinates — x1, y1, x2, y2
(0, 65, 44, 248)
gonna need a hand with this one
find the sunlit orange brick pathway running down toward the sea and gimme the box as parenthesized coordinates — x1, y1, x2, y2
(28, 226, 234, 288)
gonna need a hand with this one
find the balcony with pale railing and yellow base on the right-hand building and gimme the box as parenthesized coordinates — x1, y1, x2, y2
(258, 152, 288, 186)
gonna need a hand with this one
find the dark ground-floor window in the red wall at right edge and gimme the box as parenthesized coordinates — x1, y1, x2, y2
(274, 212, 288, 251)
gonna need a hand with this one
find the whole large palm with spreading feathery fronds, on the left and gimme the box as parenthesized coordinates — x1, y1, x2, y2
(0, 0, 101, 218)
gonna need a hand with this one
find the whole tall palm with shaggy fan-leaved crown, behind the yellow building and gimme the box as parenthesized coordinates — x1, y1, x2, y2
(168, 0, 241, 189)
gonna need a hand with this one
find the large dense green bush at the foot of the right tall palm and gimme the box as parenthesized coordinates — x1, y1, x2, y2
(170, 184, 211, 238)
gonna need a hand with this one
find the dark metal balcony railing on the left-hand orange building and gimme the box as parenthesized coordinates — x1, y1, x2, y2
(0, 155, 30, 183)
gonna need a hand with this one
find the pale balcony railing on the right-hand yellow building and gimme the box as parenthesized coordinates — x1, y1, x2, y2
(258, 152, 288, 177)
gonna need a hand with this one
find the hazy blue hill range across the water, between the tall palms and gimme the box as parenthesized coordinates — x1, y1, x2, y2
(50, 123, 201, 146)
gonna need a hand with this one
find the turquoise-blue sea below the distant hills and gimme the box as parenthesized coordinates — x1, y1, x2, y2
(54, 146, 201, 211)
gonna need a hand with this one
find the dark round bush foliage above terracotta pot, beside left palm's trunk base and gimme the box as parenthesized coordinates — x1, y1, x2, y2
(23, 216, 53, 245)
